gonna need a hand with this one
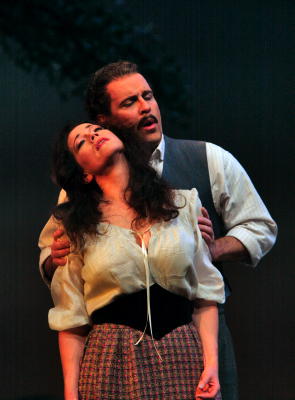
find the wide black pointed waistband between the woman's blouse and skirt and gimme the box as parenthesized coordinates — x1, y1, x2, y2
(91, 284, 193, 339)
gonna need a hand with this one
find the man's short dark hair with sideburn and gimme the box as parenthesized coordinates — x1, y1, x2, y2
(86, 61, 138, 121)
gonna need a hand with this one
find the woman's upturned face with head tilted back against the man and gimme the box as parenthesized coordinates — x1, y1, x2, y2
(68, 123, 124, 175)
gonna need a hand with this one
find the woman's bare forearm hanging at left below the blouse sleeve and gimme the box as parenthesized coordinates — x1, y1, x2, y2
(58, 325, 89, 400)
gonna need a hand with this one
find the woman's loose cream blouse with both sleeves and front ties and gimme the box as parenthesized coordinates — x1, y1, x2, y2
(49, 189, 225, 331)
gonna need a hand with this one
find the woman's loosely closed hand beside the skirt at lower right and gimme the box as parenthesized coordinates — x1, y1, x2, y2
(196, 366, 220, 400)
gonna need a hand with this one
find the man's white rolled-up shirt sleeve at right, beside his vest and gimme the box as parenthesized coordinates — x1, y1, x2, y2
(207, 143, 277, 267)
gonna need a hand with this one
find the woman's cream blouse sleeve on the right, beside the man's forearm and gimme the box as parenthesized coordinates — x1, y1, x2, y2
(188, 189, 225, 303)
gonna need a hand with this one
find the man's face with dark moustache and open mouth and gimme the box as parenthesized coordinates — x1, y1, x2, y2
(100, 73, 162, 149)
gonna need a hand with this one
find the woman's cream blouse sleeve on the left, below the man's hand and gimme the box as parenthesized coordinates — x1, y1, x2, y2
(48, 254, 91, 331)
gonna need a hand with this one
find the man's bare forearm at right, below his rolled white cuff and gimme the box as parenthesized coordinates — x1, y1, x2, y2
(210, 236, 250, 262)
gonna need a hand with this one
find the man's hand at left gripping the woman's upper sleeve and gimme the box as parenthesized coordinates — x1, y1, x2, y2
(43, 229, 71, 281)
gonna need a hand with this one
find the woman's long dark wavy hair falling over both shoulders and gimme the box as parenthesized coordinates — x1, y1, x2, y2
(52, 124, 179, 248)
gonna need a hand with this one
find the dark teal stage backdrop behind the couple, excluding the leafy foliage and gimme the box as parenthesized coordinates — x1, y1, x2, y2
(0, 0, 295, 400)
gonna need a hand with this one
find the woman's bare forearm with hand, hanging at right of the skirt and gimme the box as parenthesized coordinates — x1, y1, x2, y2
(193, 299, 220, 400)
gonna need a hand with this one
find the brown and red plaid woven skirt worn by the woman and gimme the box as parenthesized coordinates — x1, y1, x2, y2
(79, 323, 221, 400)
